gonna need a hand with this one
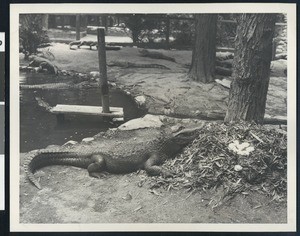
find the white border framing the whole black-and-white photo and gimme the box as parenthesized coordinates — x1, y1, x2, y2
(10, 3, 297, 232)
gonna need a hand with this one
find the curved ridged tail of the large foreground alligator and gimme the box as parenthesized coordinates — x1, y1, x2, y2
(24, 150, 91, 189)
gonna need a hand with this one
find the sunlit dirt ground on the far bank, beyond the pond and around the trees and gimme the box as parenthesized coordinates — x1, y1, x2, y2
(21, 43, 287, 119)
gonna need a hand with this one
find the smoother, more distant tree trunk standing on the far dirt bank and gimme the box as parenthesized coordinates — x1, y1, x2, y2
(189, 14, 217, 83)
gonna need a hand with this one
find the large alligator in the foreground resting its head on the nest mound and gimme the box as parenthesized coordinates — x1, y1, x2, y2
(24, 125, 203, 189)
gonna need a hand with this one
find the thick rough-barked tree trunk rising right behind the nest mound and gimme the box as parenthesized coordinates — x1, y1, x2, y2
(225, 14, 276, 123)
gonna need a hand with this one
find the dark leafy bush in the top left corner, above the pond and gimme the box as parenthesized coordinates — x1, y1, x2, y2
(19, 14, 49, 57)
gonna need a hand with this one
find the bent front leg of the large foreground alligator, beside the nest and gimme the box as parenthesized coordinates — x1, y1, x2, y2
(144, 153, 173, 177)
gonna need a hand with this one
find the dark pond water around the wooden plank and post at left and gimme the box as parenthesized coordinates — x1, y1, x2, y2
(20, 74, 144, 152)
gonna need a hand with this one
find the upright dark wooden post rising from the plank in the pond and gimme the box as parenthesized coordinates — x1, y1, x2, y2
(97, 28, 110, 113)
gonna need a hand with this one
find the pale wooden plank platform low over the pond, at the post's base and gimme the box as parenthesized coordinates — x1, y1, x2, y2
(50, 104, 124, 117)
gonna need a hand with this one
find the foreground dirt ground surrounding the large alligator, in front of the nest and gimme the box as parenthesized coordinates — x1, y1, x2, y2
(20, 118, 287, 224)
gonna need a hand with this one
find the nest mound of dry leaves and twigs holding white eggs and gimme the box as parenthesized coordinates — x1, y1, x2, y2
(146, 123, 287, 205)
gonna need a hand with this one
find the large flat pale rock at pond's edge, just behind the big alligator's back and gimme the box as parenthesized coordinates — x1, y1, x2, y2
(118, 114, 163, 130)
